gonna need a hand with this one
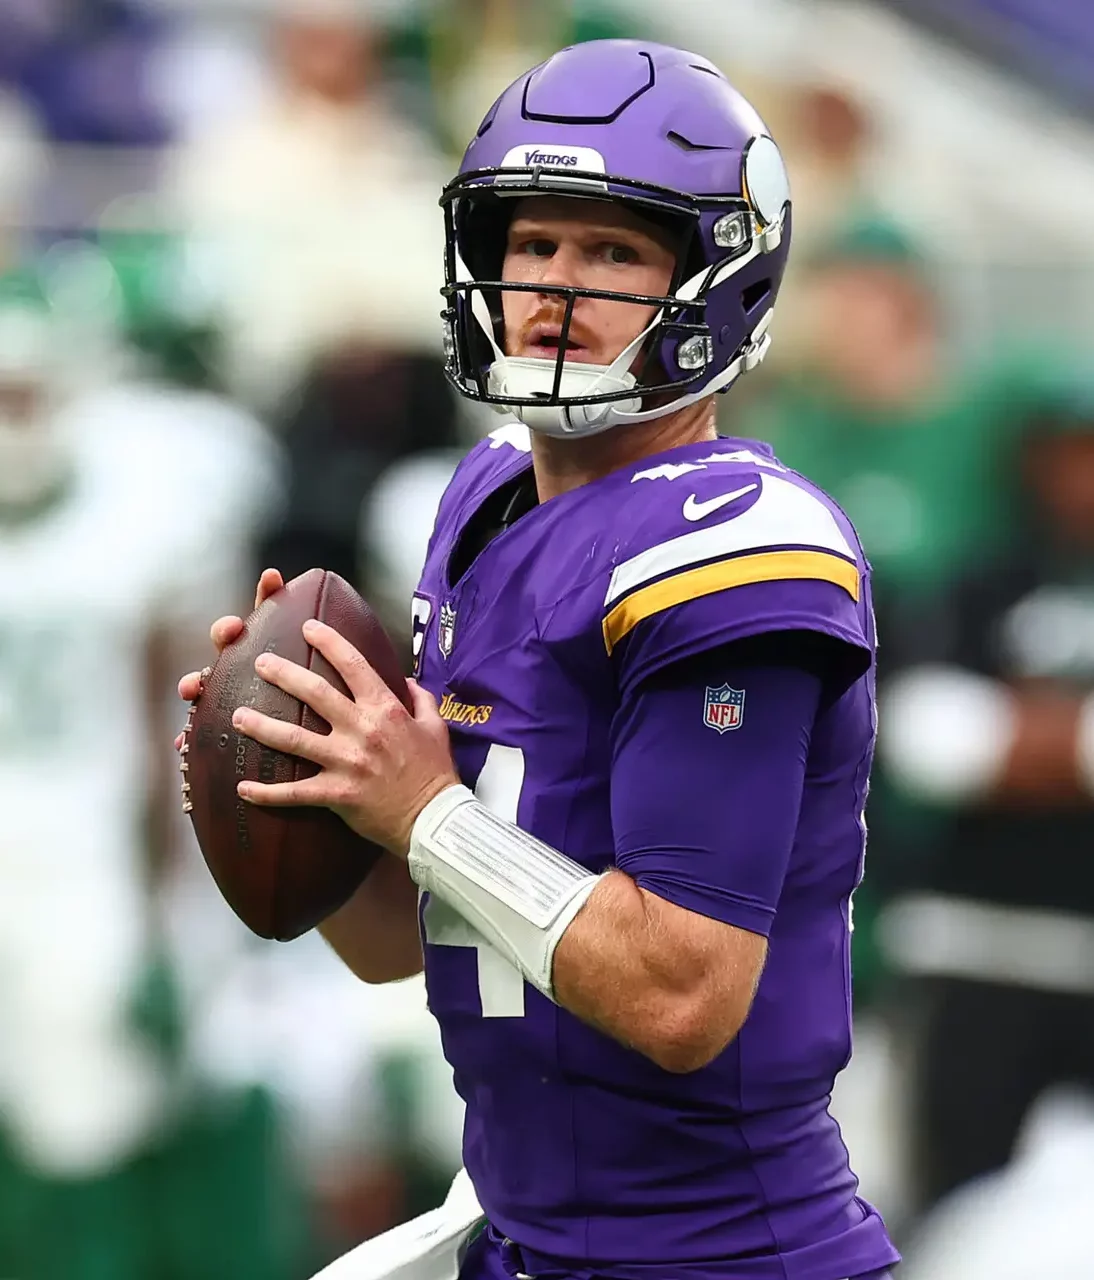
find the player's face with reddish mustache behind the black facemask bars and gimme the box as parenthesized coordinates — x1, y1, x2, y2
(502, 196, 676, 365)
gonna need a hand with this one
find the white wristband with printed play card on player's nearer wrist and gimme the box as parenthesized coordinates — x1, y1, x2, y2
(407, 786, 600, 1000)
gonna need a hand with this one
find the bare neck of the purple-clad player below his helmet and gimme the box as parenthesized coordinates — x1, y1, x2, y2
(531, 397, 718, 502)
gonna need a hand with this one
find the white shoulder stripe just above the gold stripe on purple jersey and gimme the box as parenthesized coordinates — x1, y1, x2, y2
(604, 474, 856, 607)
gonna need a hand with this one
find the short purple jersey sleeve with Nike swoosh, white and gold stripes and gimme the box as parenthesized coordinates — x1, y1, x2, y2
(601, 471, 873, 689)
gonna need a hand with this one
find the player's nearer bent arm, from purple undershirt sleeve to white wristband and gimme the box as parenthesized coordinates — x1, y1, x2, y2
(408, 649, 821, 1071)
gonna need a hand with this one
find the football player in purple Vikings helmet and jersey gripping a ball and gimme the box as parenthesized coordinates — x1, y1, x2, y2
(180, 41, 898, 1280)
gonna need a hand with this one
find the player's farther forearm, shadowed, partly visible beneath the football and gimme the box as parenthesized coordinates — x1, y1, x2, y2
(319, 854, 422, 983)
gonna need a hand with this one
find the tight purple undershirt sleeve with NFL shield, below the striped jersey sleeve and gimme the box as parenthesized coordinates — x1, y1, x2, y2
(612, 641, 823, 937)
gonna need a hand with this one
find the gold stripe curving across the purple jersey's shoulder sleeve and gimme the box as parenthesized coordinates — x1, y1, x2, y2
(604, 550, 860, 653)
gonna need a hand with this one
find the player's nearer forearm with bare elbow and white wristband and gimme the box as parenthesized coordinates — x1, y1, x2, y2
(409, 787, 765, 1071)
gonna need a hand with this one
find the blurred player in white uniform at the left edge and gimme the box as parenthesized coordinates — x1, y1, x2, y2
(0, 278, 293, 1280)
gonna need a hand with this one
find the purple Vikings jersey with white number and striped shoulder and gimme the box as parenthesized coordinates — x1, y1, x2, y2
(413, 426, 898, 1280)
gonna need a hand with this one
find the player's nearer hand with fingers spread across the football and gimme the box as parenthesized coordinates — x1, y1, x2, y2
(232, 620, 459, 858)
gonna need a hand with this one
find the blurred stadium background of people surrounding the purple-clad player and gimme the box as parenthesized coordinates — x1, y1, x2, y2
(0, 0, 1094, 1280)
